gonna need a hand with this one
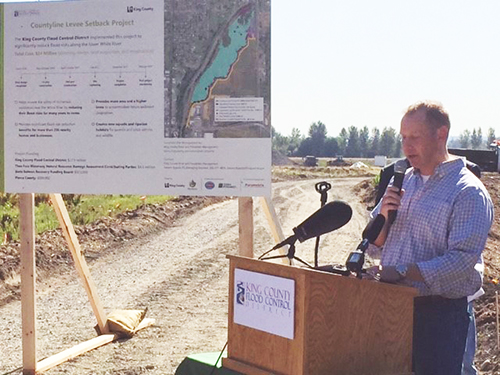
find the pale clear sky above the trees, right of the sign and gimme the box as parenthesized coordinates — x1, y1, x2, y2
(271, 0, 500, 136)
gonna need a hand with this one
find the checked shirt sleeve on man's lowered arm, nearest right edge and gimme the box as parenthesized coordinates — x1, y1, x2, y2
(417, 187, 493, 298)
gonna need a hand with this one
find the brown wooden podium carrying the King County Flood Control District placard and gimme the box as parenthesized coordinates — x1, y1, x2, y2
(223, 255, 417, 375)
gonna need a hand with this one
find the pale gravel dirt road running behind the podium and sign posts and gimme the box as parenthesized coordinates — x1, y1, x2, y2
(0, 178, 368, 375)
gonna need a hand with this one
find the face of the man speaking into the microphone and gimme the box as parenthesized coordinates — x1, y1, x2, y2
(400, 112, 443, 175)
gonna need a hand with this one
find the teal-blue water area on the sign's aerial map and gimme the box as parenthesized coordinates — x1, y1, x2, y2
(191, 12, 252, 103)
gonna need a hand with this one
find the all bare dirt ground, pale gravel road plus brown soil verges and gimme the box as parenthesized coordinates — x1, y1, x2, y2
(0, 171, 500, 375)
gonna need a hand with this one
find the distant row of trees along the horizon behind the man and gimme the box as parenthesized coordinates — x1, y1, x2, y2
(272, 121, 496, 158)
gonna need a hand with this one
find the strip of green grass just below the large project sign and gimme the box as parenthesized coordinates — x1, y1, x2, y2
(0, 194, 172, 240)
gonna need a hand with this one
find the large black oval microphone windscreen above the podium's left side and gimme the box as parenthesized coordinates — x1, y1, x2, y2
(293, 200, 352, 242)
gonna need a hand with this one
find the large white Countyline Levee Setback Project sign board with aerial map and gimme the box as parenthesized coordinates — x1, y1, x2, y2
(0, 0, 271, 196)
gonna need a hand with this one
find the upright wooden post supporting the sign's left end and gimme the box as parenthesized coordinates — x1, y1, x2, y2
(19, 194, 36, 375)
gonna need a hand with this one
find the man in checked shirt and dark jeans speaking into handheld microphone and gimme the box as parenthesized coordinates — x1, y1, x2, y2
(369, 102, 493, 375)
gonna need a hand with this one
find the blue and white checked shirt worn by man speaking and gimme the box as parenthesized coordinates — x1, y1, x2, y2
(368, 158, 493, 298)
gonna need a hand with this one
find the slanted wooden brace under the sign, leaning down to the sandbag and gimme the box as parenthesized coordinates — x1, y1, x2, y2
(50, 194, 108, 334)
